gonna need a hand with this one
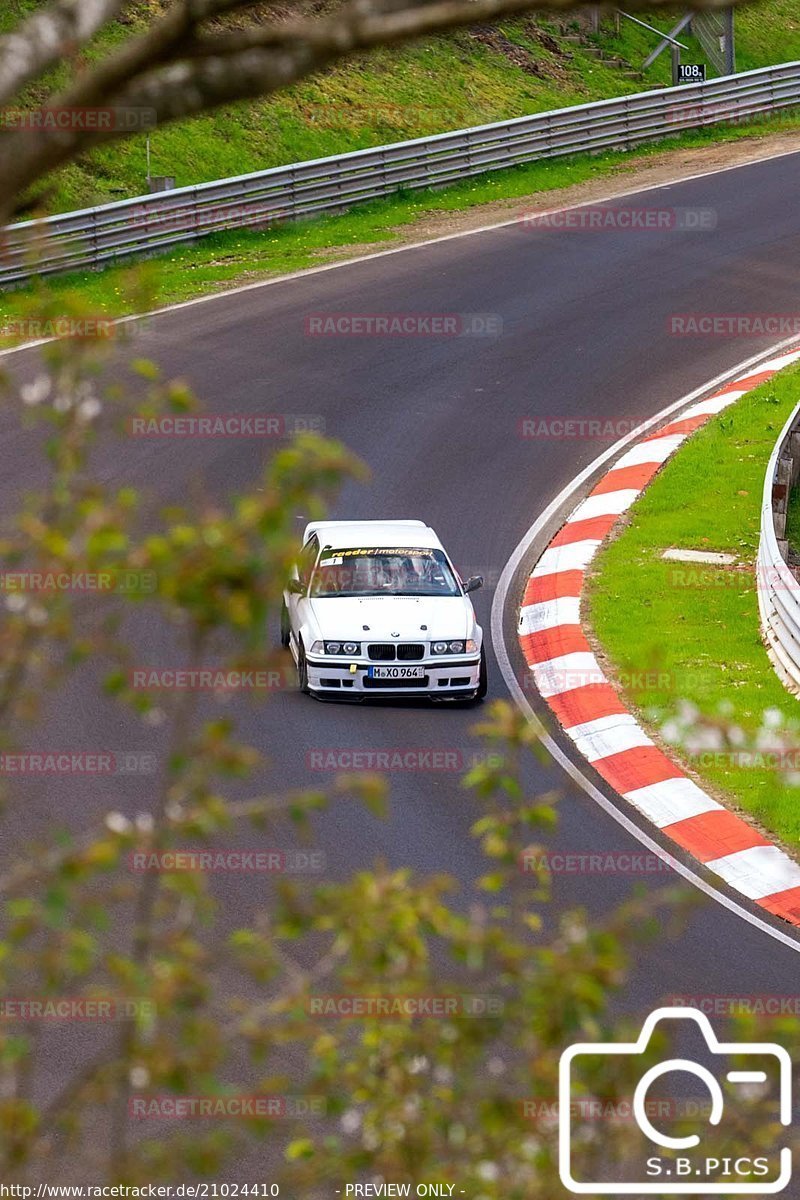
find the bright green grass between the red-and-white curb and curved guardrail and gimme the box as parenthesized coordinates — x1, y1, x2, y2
(588, 367, 800, 852)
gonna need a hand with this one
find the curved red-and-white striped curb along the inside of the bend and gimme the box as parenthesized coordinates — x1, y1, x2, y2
(518, 349, 800, 925)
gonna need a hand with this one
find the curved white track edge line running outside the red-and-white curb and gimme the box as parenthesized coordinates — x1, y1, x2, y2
(491, 333, 800, 953)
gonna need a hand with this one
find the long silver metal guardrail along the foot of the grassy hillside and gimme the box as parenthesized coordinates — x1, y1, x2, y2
(0, 62, 800, 287)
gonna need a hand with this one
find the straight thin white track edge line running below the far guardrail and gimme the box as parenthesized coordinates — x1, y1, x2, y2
(0, 148, 800, 358)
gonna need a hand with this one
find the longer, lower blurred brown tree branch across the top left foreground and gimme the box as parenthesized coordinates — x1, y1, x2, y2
(0, 0, 758, 222)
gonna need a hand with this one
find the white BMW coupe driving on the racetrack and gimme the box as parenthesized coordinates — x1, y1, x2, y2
(281, 521, 486, 700)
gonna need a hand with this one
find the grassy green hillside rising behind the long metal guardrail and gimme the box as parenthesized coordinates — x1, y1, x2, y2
(0, 0, 800, 211)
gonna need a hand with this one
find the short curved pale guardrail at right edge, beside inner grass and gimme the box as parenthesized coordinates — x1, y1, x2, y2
(757, 404, 800, 691)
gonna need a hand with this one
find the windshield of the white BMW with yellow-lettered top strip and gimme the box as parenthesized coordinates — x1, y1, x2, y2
(311, 546, 461, 596)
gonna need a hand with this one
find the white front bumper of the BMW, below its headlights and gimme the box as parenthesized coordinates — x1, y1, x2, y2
(306, 654, 481, 700)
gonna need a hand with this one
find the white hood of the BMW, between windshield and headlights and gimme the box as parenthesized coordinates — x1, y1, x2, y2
(304, 596, 475, 642)
